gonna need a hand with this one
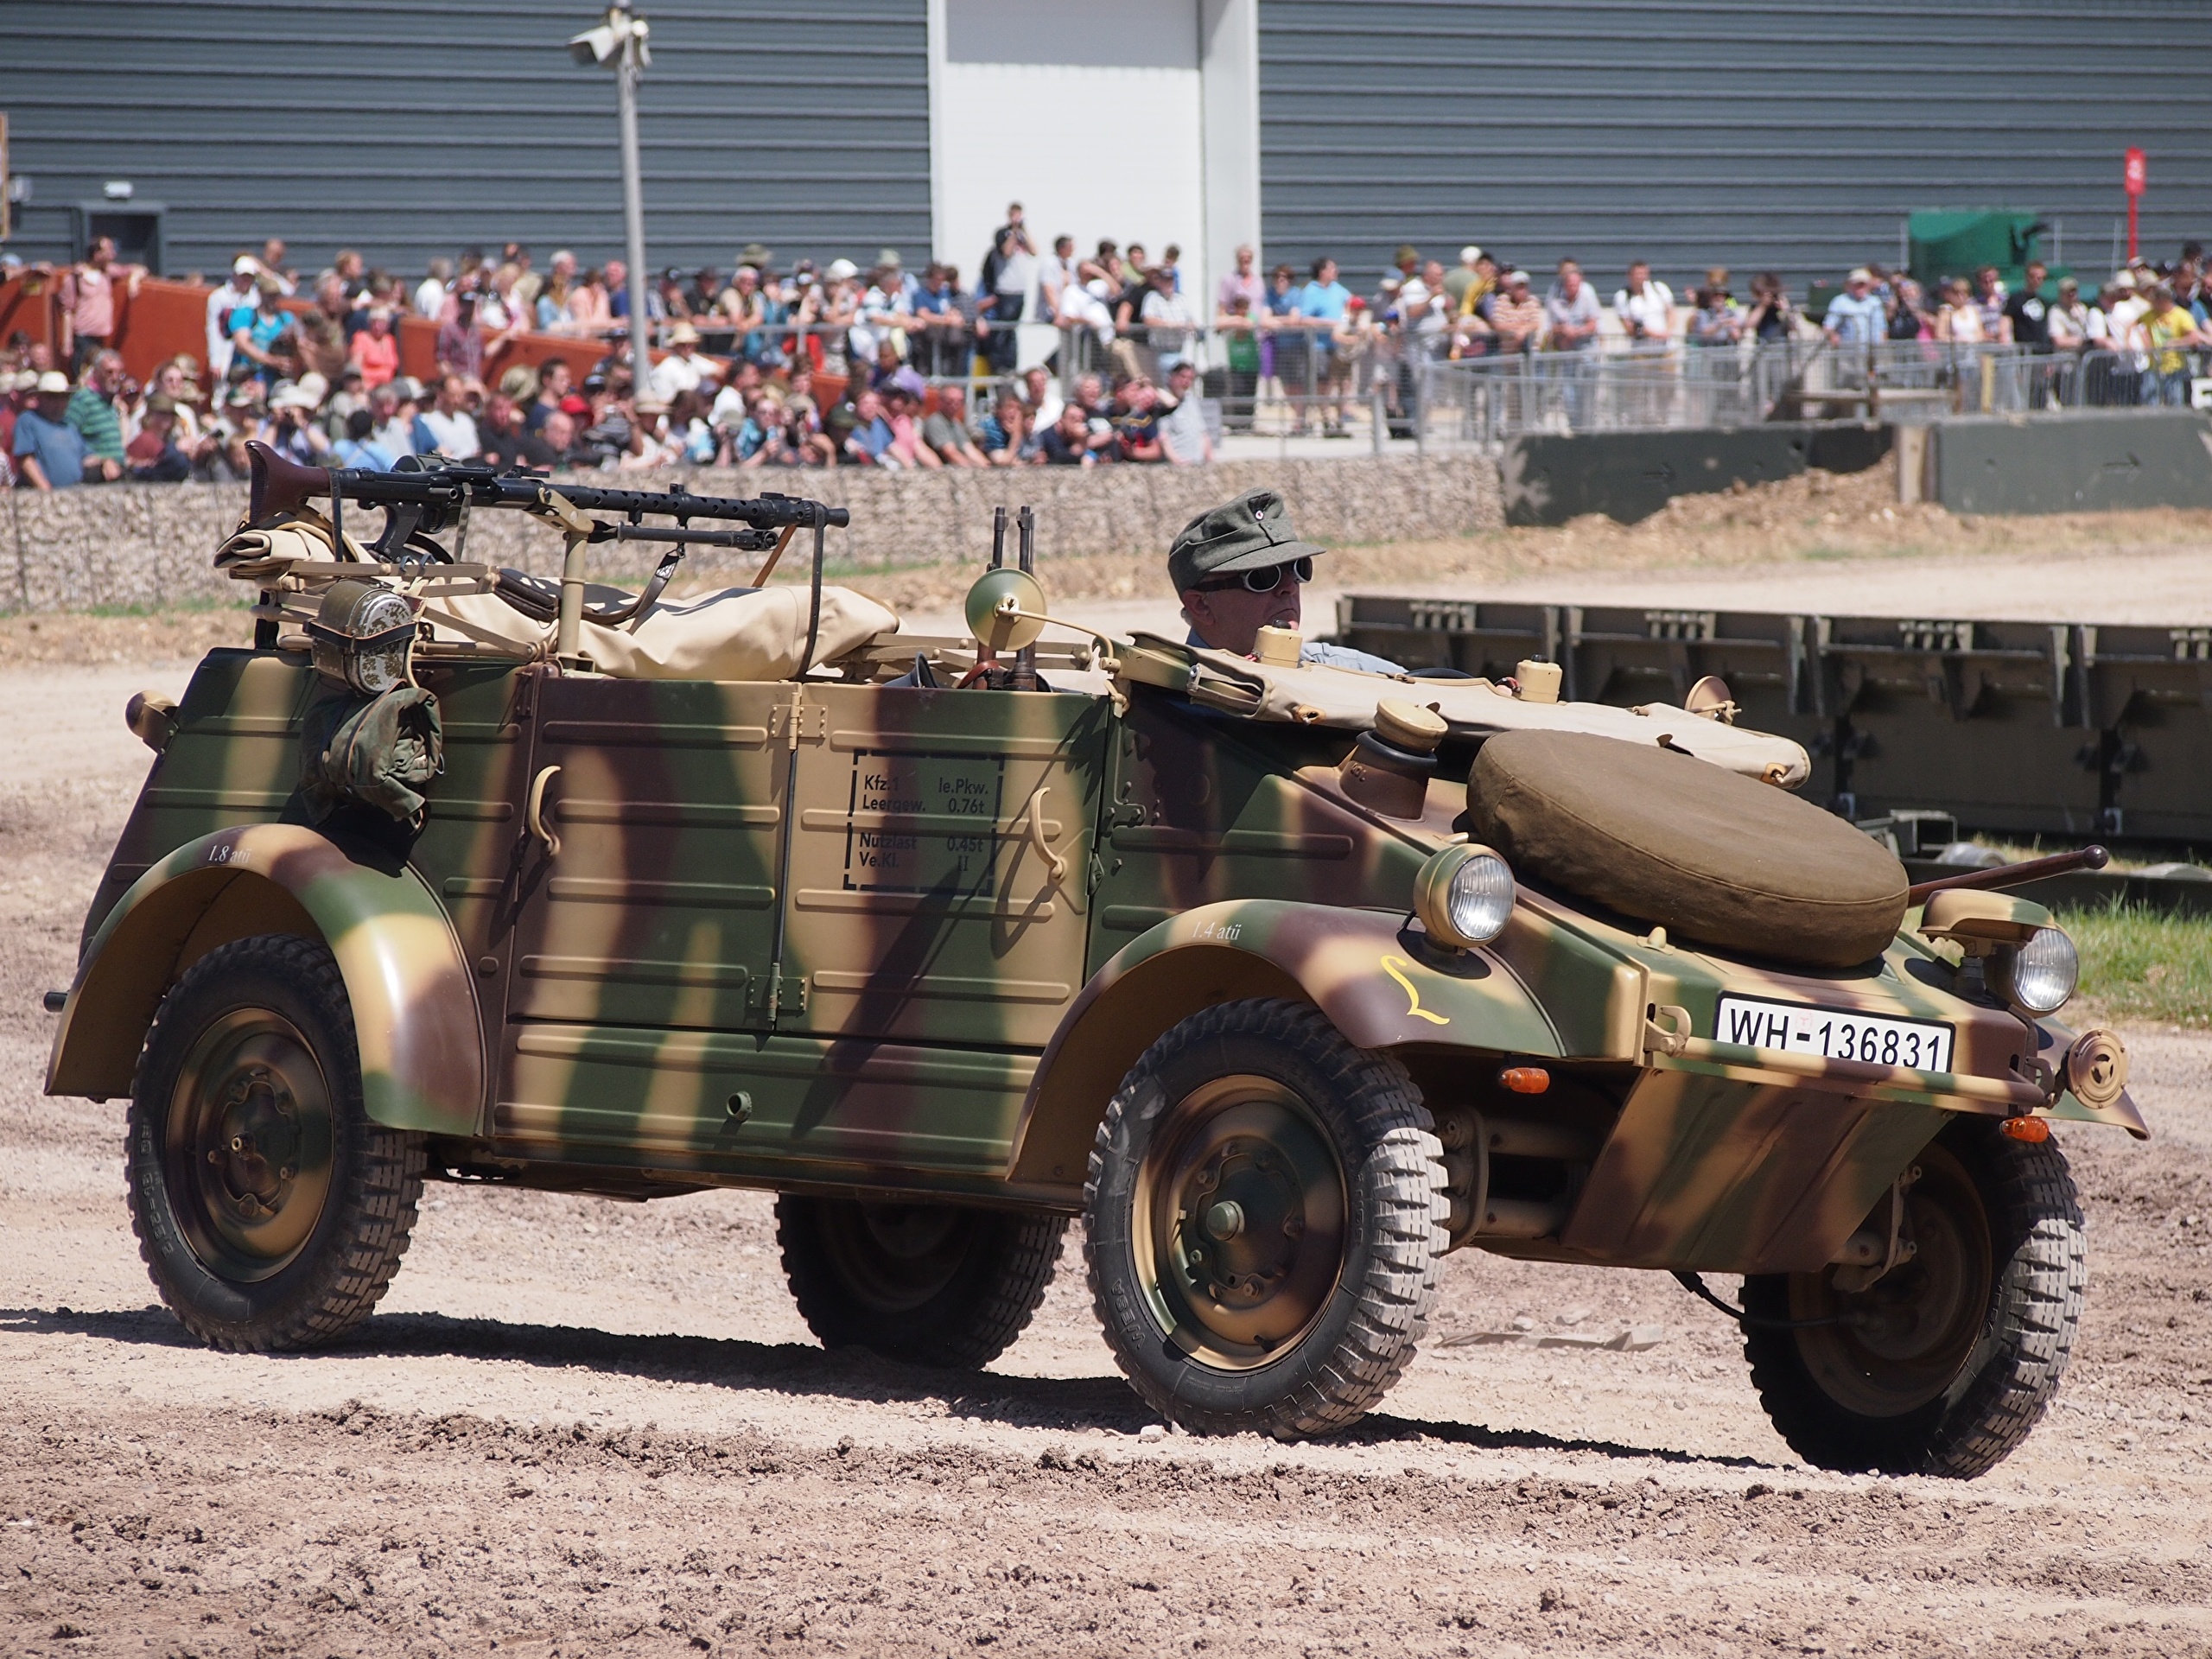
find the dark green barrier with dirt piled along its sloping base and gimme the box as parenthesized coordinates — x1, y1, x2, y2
(1497, 420, 1889, 524)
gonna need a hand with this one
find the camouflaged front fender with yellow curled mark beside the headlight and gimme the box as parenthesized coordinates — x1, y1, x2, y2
(1011, 900, 1566, 1185)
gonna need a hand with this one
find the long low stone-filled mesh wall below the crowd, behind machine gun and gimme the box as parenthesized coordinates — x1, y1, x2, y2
(0, 455, 1504, 611)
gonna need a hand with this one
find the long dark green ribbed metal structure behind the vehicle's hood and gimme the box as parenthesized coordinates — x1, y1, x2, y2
(1336, 595, 2212, 842)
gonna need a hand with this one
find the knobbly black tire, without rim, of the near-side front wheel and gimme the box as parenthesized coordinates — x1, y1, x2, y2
(1084, 998, 1449, 1440)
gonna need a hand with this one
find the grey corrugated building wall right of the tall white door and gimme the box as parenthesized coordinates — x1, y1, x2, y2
(1259, 0, 2212, 296)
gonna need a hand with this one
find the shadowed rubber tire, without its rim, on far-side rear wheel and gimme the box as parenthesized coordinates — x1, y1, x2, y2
(777, 1192, 1068, 1371)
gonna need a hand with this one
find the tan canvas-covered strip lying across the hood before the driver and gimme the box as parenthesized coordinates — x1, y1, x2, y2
(1122, 632, 1812, 790)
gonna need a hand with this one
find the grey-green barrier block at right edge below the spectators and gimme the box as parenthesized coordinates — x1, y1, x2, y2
(1927, 410, 2212, 513)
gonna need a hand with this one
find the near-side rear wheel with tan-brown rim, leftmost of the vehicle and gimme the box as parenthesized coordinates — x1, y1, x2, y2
(124, 933, 423, 1354)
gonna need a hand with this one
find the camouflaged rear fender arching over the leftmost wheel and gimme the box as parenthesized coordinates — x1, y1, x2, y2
(47, 823, 485, 1135)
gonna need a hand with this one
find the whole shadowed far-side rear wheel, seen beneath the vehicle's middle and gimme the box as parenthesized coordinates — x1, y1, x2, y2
(777, 1192, 1068, 1371)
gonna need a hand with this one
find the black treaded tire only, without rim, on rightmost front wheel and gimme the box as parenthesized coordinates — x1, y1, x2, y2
(1743, 1117, 2088, 1480)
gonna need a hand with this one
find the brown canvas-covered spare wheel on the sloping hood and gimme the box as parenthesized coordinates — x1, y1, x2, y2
(1466, 732, 1907, 967)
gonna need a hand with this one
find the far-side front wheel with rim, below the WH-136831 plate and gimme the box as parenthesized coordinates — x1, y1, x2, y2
(1743, 1117, 2088, 1480)
